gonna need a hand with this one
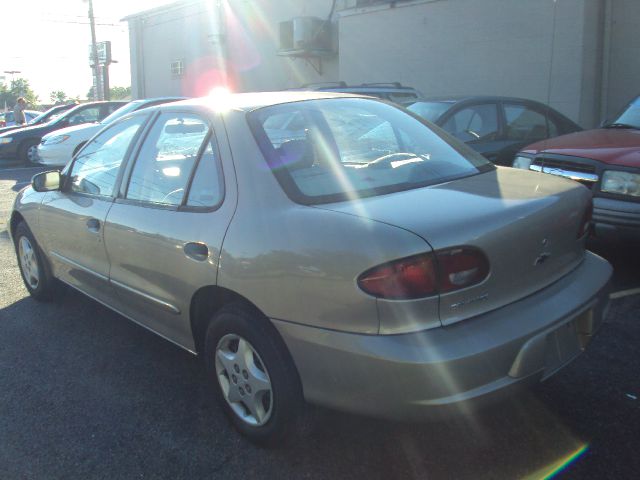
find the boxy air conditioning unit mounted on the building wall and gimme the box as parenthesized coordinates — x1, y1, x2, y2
(280, 17, 333, 53)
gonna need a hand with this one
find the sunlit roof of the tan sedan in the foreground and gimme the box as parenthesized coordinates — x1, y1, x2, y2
(162, 90, 372, 112)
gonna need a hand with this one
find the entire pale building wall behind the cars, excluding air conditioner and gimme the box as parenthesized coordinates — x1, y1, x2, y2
(129, 0, 640, 127)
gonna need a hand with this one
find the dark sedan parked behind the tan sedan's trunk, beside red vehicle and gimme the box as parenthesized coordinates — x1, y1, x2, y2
(403, 96, 582, 166)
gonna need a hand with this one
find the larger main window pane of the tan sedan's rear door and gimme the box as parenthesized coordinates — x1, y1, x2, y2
(126, 113, 209, 206)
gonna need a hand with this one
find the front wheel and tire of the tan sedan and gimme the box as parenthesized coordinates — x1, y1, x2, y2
(14, 222, 56, 302)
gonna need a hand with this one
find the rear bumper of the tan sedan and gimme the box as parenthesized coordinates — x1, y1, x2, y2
(273, 252, 612, 419)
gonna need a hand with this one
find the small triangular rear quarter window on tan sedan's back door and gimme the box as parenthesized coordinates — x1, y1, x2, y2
(187, 139, 224, 208)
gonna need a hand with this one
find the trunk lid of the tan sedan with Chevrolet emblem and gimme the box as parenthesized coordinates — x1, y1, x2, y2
(322, 167, 590, 325)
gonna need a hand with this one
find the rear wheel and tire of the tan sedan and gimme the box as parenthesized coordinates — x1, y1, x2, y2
(204, 304, 305, 445)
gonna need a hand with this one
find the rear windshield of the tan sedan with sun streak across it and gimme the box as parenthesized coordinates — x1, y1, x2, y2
(248, 98, 494, 204)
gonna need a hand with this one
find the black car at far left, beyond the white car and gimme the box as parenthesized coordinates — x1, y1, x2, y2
(0, 101, 127, 164)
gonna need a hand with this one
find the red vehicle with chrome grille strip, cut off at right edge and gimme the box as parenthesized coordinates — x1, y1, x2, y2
(513, 97, 640, 241)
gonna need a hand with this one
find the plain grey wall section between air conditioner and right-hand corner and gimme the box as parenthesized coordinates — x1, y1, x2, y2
(340, 0, 599, 124)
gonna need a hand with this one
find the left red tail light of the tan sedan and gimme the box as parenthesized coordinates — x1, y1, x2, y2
(358, 247, 489, 300)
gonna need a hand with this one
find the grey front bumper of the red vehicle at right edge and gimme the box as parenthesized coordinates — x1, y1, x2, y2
(593, 197, 640, 241)
